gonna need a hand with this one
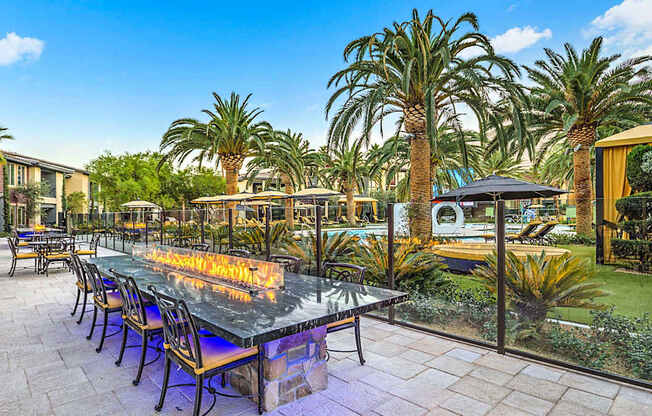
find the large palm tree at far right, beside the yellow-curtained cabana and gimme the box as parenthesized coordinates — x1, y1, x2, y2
(525, 37, 652, 234)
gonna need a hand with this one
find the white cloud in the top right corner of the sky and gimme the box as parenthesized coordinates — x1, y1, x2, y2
(587, 0, 652, 57)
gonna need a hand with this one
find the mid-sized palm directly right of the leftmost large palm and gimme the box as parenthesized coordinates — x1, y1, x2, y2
(247, 129, 319, 228)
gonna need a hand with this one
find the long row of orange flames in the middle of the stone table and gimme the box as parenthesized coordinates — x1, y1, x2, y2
(143, 247, 283, 289)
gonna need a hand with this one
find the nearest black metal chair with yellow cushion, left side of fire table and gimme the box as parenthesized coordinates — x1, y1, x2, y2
(149, 286, 265, 416)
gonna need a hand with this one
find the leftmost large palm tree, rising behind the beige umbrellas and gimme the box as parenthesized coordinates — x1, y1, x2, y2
(160, 92, 271, 195)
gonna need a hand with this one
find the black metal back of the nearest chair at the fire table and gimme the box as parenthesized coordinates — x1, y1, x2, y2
(149, 286, 202, 368)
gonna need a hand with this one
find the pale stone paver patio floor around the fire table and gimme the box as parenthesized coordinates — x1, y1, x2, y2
(0, 241, 652, 416)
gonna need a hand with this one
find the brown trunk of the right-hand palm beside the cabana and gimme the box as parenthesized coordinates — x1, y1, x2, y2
(568, 125, 595, 235)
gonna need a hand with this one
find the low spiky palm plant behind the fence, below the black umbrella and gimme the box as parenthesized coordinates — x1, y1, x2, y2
(473, 251, 607, 322)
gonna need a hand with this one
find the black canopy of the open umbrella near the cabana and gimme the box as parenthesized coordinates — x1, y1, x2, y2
(433, 175, 567, 201)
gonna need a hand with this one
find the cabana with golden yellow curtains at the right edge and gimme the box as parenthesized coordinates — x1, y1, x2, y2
(595, 124, 652, 264)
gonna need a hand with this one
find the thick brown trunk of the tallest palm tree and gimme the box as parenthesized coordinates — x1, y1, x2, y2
(403, 104, 432, 242)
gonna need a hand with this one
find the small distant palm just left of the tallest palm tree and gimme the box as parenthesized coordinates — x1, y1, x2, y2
(322, 144, 366, 225)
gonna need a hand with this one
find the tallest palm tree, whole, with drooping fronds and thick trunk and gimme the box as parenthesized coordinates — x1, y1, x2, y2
(326, 9, 519, 241)
